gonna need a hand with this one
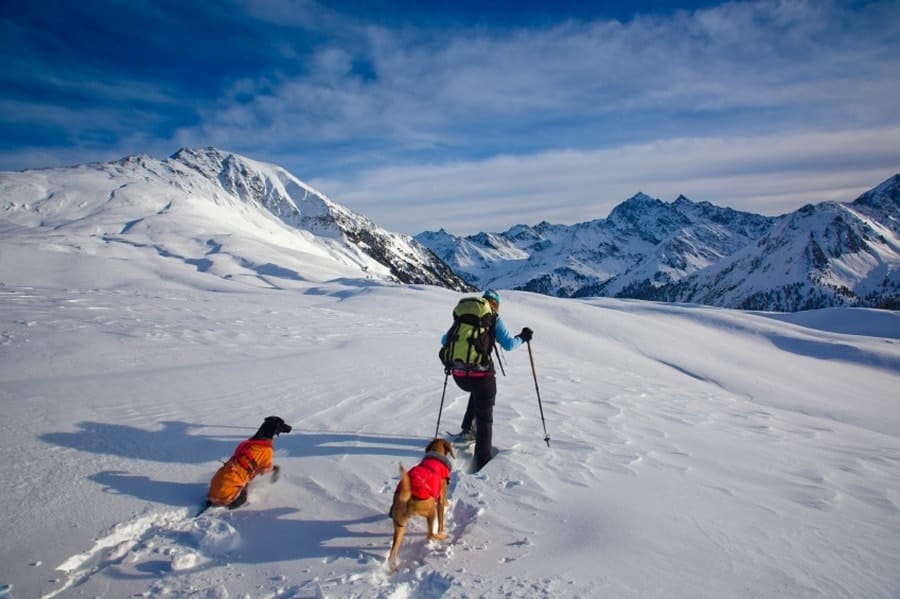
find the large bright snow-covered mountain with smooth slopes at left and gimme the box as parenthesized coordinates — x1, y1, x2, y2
(0, 148, 470, 290)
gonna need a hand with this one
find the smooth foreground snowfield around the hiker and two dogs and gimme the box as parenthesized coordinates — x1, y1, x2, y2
(0, 238, 900, 599)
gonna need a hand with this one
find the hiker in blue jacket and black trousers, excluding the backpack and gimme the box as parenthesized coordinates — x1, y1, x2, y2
(441, 289, 533, 470)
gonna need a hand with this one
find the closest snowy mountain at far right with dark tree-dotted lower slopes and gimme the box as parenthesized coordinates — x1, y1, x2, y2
(658, 175, 900, 312)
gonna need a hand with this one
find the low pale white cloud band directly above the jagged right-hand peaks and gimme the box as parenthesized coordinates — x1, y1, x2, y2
(310, 127, 900, 234)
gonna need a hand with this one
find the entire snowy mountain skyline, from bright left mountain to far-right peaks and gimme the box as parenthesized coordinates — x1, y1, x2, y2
(0, 148, 900, 311)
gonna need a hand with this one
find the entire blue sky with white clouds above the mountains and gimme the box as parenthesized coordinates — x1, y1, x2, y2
(0, 0, 900, 234)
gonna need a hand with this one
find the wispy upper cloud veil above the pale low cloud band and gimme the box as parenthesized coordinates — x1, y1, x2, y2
(171, 2, 900, 168)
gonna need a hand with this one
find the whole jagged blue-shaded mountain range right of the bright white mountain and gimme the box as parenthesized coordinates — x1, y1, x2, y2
(416, 175, 900, 311)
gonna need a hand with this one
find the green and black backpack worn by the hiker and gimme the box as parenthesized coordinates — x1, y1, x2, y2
(438, 297, 497, 374)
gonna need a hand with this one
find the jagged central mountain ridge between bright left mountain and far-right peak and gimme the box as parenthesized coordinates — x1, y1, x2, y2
(416, 193, 773, 297)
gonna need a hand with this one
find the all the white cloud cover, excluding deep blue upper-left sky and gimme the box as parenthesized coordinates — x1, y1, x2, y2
(7, 0, 900, 239)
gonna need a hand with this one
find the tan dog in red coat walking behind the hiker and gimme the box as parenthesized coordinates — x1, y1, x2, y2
(388, 439, 456, 570)
